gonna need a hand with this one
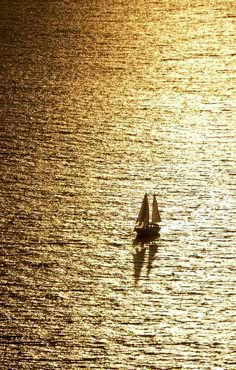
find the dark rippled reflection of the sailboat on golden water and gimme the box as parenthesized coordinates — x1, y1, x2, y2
(133, 234, 160, 285)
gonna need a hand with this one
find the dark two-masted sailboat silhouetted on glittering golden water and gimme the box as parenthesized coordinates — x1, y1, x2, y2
(134, 193, 161, 237)
